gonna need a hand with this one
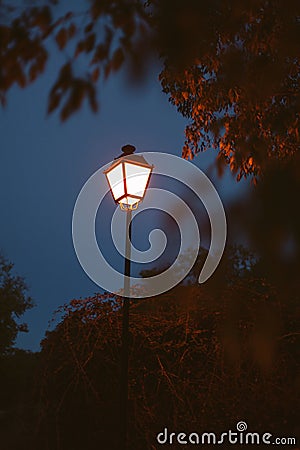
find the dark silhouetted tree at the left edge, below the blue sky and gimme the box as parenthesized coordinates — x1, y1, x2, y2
(0, 255, 36, 450)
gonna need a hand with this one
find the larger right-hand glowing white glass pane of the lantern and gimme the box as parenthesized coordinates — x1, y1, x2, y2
(125, 162, 151, 201)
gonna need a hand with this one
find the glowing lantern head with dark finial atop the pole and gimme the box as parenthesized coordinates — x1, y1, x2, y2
(104, 145, 153, 210)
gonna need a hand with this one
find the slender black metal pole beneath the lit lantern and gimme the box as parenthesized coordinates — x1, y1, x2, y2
(120, 209, 132, 450)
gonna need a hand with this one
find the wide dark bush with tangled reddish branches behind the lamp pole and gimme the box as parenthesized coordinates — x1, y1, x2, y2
(35, 248, 299, 450)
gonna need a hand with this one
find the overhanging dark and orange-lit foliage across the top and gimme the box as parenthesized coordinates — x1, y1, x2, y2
(0, 0, 300, 179)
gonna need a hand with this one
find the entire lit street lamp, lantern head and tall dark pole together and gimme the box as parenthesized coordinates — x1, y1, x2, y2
(104, 145, 153, 450)
